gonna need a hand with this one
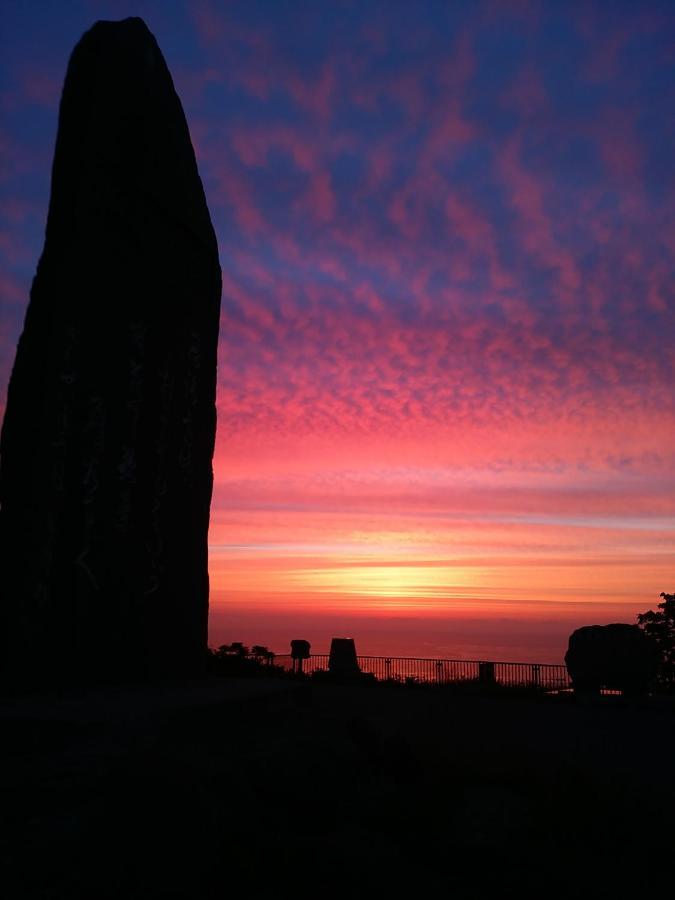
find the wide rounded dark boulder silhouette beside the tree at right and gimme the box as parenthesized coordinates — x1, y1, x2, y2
(565, 623, 659, 694)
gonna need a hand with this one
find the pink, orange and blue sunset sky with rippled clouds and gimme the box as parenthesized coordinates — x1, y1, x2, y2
(0, 0, 675, 662)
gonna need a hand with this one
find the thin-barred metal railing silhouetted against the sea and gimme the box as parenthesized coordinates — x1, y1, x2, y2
(274, 653, 571, 691)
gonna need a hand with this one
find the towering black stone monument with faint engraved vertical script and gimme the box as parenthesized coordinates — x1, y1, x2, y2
(0, 18, 221, 682)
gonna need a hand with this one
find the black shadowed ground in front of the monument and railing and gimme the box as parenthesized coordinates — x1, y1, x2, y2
(0, 679, 675, 900)
